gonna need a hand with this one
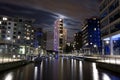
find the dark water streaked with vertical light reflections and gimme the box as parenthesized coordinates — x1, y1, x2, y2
(0, 58, 120, 80)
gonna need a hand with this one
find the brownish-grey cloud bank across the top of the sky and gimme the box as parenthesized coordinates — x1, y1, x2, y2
(2, 0, 98, 20)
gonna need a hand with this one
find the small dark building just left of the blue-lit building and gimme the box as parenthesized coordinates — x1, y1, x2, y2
(74, 32, 82, 51)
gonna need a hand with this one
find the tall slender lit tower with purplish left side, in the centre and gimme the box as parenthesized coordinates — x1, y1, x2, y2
(54, 19, 67, 53)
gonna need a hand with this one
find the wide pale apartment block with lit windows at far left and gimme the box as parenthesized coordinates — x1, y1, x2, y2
(0, 15, 34, 54)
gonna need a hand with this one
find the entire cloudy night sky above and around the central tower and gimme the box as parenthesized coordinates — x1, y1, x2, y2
(0, 0, 100, 41)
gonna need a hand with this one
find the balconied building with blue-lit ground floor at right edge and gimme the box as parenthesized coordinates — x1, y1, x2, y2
(99, 0, 120, 55)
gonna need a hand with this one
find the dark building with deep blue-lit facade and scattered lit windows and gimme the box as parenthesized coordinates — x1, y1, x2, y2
(82, 17, 101, 54)
